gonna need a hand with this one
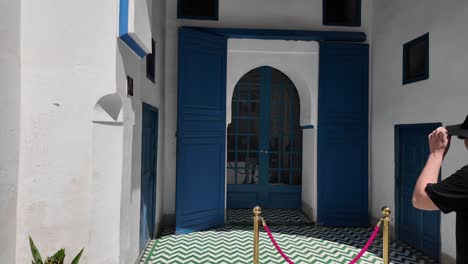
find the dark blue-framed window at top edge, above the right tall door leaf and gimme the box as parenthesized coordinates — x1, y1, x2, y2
(323, 0, 361, 27)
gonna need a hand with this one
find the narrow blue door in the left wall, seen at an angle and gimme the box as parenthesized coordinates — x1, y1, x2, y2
(140, 104, 158, 251)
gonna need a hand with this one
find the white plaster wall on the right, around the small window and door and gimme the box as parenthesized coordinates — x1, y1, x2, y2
(371, 0, 468, 263)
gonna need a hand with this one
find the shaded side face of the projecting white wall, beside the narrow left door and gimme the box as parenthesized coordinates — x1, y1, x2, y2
(116, 39, 145, 263)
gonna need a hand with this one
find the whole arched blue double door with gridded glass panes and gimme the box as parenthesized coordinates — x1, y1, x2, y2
(226, 66, 302, 208)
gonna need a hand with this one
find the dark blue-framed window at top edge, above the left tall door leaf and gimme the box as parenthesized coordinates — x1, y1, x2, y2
(177, 0, 219, 20)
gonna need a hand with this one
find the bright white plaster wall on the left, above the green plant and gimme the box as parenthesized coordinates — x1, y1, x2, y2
(10, 0, 160, 264)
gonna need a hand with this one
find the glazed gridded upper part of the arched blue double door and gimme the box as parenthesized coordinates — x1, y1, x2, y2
(227, 67, 302, 188)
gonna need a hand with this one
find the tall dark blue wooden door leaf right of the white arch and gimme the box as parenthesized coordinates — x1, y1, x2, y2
(317, 42, 369, 226)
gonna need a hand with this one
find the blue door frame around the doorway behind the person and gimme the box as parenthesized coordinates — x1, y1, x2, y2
(393, 122, 442, 258)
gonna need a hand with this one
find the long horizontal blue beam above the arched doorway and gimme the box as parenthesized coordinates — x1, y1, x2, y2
(182, 27, 367, 42)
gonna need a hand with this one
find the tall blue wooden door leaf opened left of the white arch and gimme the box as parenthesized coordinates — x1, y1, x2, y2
(176, 28, 227, 233)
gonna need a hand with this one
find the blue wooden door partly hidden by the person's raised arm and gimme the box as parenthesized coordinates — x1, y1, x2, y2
(395, 123, 441, 260)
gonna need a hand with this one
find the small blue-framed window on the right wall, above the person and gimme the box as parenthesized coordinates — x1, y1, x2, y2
(403, 33, 429, 85)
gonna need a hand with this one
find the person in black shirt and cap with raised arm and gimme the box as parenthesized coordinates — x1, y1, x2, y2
(412, 116, 468, 264)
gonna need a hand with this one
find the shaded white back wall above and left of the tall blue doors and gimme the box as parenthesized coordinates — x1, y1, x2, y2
(163, 0, 372, 222)
